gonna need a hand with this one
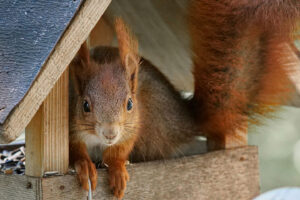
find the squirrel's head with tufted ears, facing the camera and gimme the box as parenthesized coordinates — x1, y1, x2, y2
(70, 19, 139, 146)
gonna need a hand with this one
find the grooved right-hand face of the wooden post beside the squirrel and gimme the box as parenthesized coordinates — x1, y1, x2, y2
(42, 69, 69, 173)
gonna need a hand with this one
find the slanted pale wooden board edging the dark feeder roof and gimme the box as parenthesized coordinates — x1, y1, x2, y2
(0, 0, 111, 143)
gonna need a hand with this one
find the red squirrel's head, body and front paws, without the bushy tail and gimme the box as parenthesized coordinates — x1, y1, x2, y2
(70, 19, 200, 198)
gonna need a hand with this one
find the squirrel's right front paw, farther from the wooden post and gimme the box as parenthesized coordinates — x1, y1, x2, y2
(108, 166, 129, 199)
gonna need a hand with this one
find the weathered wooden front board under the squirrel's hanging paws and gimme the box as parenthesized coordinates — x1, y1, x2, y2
(42, 146, 259, 200)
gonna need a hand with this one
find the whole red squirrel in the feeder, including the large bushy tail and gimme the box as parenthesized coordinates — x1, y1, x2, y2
(70, 0, 300, 198)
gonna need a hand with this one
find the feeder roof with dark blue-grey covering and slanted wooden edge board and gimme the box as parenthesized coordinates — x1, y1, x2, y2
(0, 0, 110, 143)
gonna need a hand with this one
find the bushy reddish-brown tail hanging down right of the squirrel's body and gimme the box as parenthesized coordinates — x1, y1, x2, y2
(189, 0, 300, 148)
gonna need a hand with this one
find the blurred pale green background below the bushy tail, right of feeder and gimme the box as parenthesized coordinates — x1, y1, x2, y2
(248, 106, 300, 192)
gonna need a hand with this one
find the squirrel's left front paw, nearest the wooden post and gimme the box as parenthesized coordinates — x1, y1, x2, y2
(74, 159, 98, 191)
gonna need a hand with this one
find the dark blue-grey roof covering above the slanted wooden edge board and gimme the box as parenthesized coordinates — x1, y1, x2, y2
(0, 0, 82, 124)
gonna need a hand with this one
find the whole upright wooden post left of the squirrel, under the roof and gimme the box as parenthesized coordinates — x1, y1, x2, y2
(25, 69, 69, 177)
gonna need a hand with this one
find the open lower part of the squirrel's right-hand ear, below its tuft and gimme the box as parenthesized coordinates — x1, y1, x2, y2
(125, 53, 139, 93)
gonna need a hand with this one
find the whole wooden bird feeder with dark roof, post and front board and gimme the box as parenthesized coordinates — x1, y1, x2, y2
(0, 0, 259, 200)
